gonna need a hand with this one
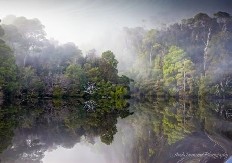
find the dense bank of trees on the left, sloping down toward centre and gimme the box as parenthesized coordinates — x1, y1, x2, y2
(0, 16, 130, 99)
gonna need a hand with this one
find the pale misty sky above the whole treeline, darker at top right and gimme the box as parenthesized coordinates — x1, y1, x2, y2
(0, 0, 232, 70)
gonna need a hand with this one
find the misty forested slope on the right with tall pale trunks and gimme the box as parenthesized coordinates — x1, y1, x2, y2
(124, 12, 232, 98)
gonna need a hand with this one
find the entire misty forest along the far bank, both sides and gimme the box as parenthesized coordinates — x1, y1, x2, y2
(0, 11, 232, 99)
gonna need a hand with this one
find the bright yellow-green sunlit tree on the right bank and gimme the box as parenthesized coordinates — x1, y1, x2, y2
(163, 46, 194, 95)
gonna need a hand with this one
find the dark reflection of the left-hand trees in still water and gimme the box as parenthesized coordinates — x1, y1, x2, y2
(0, 100, 132, 162)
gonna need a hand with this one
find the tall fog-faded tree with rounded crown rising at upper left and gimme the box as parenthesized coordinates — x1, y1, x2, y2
(3, 16, 46, 67)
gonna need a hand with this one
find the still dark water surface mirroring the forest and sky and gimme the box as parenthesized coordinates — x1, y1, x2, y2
(0, 100, 232, 163)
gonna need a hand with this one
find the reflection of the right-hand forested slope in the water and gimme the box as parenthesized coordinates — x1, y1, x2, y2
(129, 100, 232, 163)
